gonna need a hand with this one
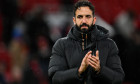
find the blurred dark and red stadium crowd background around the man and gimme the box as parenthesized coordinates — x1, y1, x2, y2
(0, 0, 140, 84)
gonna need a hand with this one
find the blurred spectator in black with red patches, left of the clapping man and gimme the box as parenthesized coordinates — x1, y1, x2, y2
(22, 7, 53, 84)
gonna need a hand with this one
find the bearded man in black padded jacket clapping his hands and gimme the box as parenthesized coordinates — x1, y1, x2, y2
(48, 1, 124, 84)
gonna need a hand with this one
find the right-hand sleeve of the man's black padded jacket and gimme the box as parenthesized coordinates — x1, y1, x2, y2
(94, 40, 124, 84)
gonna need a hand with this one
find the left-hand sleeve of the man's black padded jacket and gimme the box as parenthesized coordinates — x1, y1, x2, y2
(48, 39, 81, 84)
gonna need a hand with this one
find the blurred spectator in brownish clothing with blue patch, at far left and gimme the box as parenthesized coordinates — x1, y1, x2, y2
(9, 20, 28, 84)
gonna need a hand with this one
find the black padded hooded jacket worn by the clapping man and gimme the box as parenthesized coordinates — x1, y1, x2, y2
(48, 25, 124, 84)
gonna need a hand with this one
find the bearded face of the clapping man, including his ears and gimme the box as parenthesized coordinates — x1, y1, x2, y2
(73, 6, 96, 30)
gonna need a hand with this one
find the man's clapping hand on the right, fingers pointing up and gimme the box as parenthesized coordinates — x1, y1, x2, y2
(87, 50, 100, 73)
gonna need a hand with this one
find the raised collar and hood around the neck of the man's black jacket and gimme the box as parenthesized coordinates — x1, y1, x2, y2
(67, 25, 109, 49)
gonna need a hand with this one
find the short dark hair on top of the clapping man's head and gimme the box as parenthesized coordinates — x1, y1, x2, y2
(73, 0, 95, 17)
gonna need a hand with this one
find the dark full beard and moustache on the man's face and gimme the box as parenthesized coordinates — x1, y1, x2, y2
(76, 23, 94, 33)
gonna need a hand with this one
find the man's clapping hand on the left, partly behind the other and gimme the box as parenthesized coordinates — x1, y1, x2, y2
(78, 51, 92, 75)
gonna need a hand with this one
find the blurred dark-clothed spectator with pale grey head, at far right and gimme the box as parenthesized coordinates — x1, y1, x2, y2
(113, 11, 140, 84)
